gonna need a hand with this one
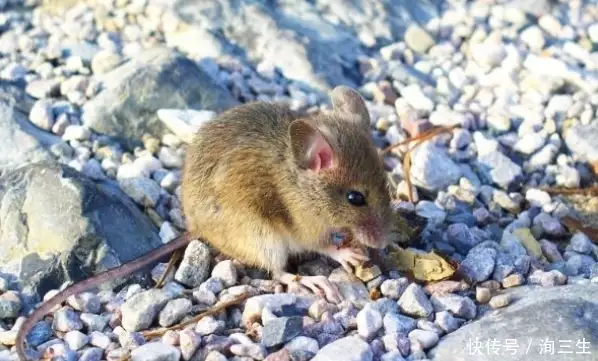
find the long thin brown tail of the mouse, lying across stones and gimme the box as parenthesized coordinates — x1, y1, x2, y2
(16, 233, 191, 361)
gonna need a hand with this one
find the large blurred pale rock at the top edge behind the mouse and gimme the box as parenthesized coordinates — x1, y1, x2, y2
(171, 0, 437, 91)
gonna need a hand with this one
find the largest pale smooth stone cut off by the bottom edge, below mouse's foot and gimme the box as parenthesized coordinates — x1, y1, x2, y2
(311, 336, 374, 361)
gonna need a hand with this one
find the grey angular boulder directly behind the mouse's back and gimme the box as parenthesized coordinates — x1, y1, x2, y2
(83, 48, 237, 147)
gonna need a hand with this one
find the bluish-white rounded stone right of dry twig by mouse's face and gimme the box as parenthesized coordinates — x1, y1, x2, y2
(410, 142, 462, 191)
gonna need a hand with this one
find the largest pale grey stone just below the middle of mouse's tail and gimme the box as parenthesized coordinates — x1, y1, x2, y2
(121, 289, 168, 332)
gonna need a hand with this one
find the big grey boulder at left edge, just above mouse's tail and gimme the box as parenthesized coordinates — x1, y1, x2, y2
(0, 163, 162, 296)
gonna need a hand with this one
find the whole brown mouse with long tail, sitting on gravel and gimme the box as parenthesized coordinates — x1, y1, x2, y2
(16, 86, 391, 361)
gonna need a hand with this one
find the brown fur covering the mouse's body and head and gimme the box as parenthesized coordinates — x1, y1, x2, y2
(182, 87, 390, 272)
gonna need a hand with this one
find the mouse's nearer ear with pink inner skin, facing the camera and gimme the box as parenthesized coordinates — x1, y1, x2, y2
(289, 119, 335, 172)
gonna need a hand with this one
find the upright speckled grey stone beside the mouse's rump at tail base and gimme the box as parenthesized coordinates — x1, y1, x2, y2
(174, 240, 211, 287)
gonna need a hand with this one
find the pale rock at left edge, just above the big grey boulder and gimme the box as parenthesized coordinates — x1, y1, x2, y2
(0, 80, 60, 174)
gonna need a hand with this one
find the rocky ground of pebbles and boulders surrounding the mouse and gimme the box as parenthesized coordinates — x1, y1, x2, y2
(0, 0, 598, 361)
